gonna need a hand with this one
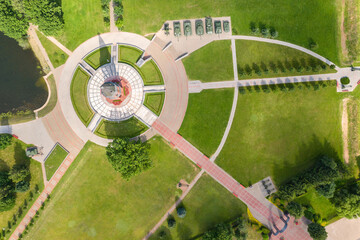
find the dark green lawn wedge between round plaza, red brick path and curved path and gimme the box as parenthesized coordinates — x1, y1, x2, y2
(179, 89, 234, 157)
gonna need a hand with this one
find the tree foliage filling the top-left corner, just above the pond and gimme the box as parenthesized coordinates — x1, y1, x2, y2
(0, 0, 29, 40)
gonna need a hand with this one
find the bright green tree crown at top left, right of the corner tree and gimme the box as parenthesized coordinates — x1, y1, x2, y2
(24, 0, 64, 36)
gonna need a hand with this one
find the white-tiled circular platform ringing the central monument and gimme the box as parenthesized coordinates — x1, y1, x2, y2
(87, 63, 144, 121)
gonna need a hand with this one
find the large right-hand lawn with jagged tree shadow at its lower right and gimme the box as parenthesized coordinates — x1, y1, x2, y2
(216, 87, 344, 186)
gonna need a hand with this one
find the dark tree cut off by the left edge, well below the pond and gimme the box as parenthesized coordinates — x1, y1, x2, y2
(0, 172, 15, 212)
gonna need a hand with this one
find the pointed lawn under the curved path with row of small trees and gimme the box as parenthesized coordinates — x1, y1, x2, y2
(236, 40, 336, 79)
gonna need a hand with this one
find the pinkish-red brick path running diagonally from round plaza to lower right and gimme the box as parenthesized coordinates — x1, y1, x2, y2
(152, 120, 311, 240)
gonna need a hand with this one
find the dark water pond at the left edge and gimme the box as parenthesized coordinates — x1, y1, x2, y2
(0, 32, 48, 114)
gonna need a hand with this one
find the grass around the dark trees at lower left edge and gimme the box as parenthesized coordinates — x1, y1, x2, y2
(0, 135, 44, 231)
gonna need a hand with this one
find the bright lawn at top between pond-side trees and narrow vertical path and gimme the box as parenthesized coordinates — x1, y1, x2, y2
(58, 0, 109, 51)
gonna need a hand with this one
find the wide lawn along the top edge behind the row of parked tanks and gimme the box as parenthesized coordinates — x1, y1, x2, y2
(123, 0, 340, 63)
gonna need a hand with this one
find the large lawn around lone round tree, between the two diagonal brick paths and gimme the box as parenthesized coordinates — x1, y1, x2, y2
(25, 137, 199, 240)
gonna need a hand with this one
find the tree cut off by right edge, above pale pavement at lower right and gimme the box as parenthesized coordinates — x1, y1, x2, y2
(331, 181, 360, 218)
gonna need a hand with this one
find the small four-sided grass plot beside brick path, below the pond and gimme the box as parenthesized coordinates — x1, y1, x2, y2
(45, 144, 68, 181)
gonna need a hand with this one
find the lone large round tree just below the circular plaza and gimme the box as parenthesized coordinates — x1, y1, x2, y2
(106, 138, 153, 180)
